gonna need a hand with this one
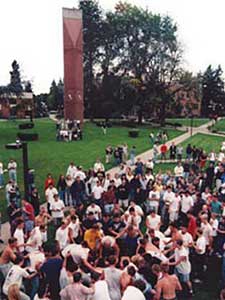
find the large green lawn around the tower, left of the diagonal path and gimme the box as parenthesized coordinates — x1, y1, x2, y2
(0, 119, 182, 221)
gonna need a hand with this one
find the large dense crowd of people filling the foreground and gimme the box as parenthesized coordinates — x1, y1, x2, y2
(0, 144, 225, 300)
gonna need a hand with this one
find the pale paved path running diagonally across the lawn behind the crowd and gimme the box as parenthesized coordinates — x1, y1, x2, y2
(0, 118, 221, 251)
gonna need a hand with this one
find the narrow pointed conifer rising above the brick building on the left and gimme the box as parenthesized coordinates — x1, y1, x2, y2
(8, 60, 23, 96)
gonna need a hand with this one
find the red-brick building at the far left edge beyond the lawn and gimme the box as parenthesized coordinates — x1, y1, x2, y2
(0, 92, 34, 119)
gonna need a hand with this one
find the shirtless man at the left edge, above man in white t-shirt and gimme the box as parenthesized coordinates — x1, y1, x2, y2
(0, 238, 17, 277)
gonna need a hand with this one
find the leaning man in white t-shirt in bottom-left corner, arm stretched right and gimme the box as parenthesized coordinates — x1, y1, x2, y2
(2, 256, 37, 300)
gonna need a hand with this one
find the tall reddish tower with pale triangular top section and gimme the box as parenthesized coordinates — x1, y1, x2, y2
(63, 8, 84, 124)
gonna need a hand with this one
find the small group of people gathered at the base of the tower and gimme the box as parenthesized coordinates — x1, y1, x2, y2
(56, 119, 83, 142)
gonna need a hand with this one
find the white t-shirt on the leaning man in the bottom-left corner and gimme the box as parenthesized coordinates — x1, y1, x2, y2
(3, 265, 30, 295)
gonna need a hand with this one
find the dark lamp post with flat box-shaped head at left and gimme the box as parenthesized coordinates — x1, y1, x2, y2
(5, 142, 29, 200)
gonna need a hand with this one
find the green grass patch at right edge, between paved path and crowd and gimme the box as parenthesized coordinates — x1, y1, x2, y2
(179, 133, 225, 153)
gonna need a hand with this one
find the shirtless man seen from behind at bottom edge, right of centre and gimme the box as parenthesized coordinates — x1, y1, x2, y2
(154, 263, 182, 300)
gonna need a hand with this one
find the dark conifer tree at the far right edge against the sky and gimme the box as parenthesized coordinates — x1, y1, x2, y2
(201, 65, 225, 117)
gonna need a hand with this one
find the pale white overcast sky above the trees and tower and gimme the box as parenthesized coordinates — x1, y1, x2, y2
(0, 0, 225, 94)
